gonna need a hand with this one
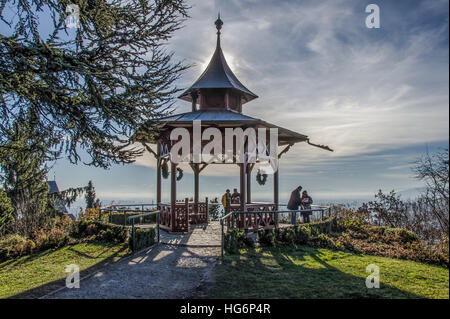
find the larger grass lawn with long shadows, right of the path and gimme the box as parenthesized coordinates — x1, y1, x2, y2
(211, 247, 449, 299)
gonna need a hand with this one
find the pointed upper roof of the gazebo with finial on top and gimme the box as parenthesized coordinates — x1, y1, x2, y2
(179, 16, 258, 103)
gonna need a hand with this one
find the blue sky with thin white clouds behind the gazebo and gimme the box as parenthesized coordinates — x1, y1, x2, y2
(49, 0, 449, 210)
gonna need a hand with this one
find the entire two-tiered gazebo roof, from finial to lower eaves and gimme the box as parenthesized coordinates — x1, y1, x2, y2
(134, 16, 332, 154)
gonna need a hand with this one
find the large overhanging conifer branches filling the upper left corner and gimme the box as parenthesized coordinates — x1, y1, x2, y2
(0, 0, 188, 167)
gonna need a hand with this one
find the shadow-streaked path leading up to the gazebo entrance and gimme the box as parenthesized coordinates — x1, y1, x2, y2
(47, 222, 220, 299)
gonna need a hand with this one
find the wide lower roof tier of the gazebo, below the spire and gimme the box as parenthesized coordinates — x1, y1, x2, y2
(149, 110, 309, 145)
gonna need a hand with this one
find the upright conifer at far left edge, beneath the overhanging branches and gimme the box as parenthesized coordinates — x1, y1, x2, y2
(0, 111, 59, 235)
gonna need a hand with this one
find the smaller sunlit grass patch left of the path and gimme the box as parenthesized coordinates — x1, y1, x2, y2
(0, 243, 129, 298)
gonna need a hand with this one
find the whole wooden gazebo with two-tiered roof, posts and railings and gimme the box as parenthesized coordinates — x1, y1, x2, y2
(137, 16, 330, 232)
